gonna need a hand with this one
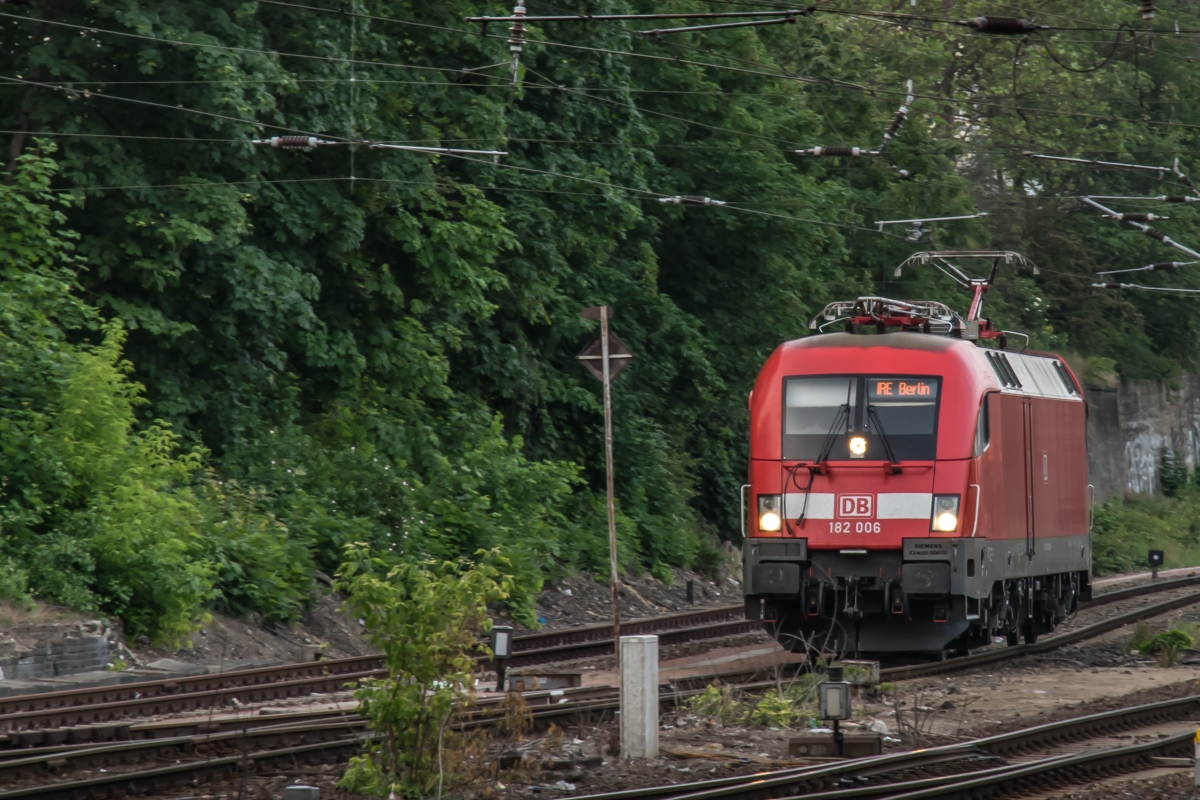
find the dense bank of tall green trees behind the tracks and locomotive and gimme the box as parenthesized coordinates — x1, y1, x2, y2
(11, 0, 1200, 636)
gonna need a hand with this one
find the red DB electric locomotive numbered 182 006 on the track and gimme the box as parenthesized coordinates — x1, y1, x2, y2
(743, 255, 1091, 656)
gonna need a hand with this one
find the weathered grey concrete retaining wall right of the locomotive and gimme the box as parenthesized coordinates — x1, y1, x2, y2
(1086, 375, 1200, 500)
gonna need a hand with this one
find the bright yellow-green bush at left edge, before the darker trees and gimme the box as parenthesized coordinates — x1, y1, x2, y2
(0, 148, 311, 642)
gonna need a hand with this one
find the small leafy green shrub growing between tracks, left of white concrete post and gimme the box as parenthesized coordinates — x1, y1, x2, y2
(336, 542, 512, 798)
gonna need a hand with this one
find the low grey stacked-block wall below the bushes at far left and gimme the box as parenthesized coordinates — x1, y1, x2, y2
(0, 620, 122, 680)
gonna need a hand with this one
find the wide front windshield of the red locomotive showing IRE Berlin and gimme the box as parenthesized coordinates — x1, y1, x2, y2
(782, 375, 941, 462)
